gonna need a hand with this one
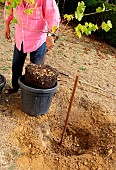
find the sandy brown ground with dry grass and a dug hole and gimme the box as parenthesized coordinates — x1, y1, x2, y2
(0, 3, 116, 170)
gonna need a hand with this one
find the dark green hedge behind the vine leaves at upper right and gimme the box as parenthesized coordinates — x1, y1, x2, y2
(59, 0, 116, 47)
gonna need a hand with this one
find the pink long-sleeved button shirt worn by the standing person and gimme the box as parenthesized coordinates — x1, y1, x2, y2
(4, 0, 60, 53)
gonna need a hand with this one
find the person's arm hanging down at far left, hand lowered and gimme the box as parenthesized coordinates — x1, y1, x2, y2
(4, 2, 13, 39)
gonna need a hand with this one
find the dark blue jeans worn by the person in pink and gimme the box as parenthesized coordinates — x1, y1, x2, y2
(12, 42, 46, 89)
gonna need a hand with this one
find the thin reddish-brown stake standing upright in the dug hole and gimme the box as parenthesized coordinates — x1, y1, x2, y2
(59, 76, 78, 146)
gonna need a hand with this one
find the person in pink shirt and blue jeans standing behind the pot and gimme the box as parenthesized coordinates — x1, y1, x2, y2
(4, 0, 60, 94)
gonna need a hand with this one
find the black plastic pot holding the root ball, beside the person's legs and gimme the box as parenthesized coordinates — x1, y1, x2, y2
(18, 75, 58, 116)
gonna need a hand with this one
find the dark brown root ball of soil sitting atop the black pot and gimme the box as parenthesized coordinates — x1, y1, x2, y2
(25, 63, 59, 89)
